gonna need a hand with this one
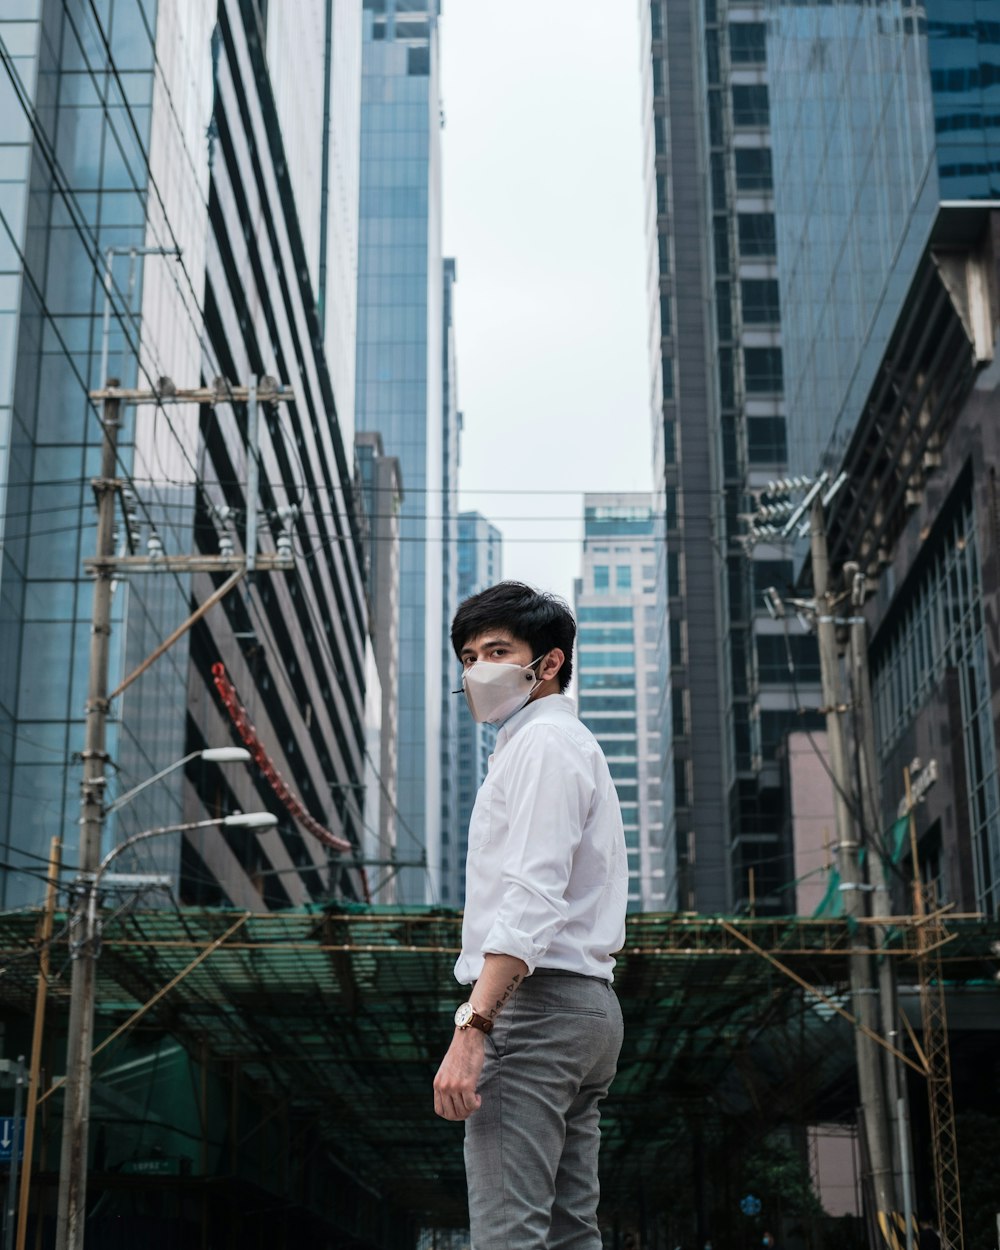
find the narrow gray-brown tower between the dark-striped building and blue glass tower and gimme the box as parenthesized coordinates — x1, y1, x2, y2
(354, 434, 397, 903)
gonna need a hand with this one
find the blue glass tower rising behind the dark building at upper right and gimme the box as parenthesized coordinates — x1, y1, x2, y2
(766, 0, 1000, 474)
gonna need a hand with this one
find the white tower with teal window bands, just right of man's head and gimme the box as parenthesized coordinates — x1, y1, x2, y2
(575, 494, 678, 911)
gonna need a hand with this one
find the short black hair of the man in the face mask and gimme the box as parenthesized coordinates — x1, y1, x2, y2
(451, 581, 576, 690)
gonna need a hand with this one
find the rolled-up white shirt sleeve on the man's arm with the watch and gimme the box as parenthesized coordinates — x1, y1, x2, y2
(483, 724, 595, 973)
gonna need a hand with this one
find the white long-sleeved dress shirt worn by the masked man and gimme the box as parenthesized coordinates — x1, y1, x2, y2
(455, 695, 629, 984)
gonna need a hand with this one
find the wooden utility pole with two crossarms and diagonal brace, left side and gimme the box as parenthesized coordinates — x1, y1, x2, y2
(55, 378, 294, 1250)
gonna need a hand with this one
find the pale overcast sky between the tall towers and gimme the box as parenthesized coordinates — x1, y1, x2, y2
(441, 0, 653, 603)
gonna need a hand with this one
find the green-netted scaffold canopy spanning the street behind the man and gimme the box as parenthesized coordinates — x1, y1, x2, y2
(0, 905, 1000, 1224)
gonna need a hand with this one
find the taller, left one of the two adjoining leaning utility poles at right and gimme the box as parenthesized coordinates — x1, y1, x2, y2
(810, 495, 899, 1246)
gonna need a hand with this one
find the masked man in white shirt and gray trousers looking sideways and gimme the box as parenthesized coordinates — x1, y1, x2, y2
(434, 581, 628, 1250)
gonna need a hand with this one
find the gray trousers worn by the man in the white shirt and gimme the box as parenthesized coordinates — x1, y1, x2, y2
(465, 969, 623, 1250)
